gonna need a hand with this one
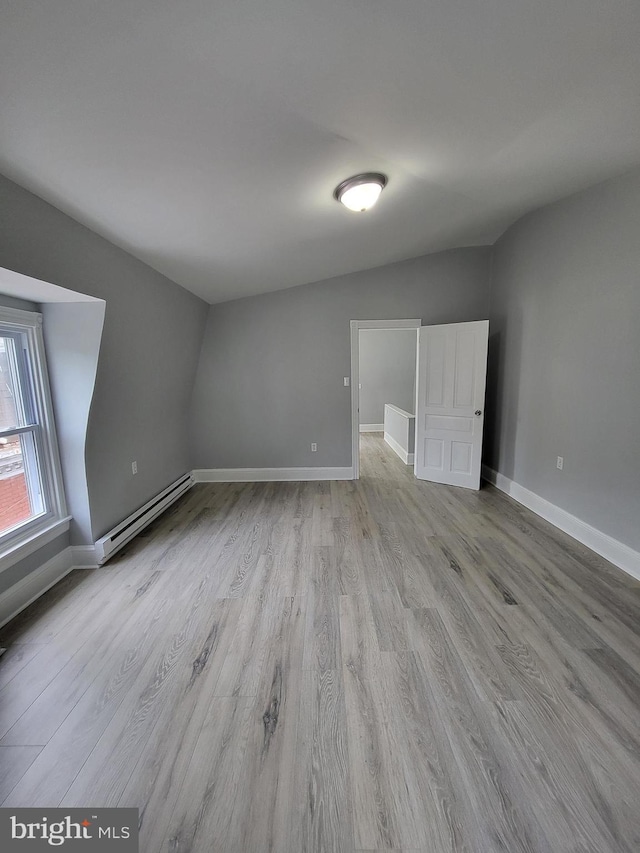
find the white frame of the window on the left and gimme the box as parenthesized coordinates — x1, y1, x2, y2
(0, 306, 70, 572)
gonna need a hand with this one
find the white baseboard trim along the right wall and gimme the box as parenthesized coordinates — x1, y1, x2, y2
(482, 465, 640, 580)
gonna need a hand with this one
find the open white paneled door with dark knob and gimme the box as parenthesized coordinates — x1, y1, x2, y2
(414, 320, 489, 489)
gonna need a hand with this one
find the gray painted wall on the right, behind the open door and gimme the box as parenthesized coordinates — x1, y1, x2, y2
(485, 170, 640, 549)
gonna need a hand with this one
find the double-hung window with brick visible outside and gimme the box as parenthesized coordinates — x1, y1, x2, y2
(0, 307, 66, 553)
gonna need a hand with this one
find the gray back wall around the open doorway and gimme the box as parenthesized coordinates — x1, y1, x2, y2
(190, 248, 490, 468)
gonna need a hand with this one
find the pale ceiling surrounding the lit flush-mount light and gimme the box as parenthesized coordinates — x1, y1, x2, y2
(0, 0, 640, 302)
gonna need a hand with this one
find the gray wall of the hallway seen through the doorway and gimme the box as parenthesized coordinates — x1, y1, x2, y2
(359, 329, 416, 424)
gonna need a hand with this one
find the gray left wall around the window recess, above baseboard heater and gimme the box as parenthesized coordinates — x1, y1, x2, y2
(0, 177, 208, 538)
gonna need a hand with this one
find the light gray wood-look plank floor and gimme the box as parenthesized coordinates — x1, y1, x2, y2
(0, 436, 640, 853)
